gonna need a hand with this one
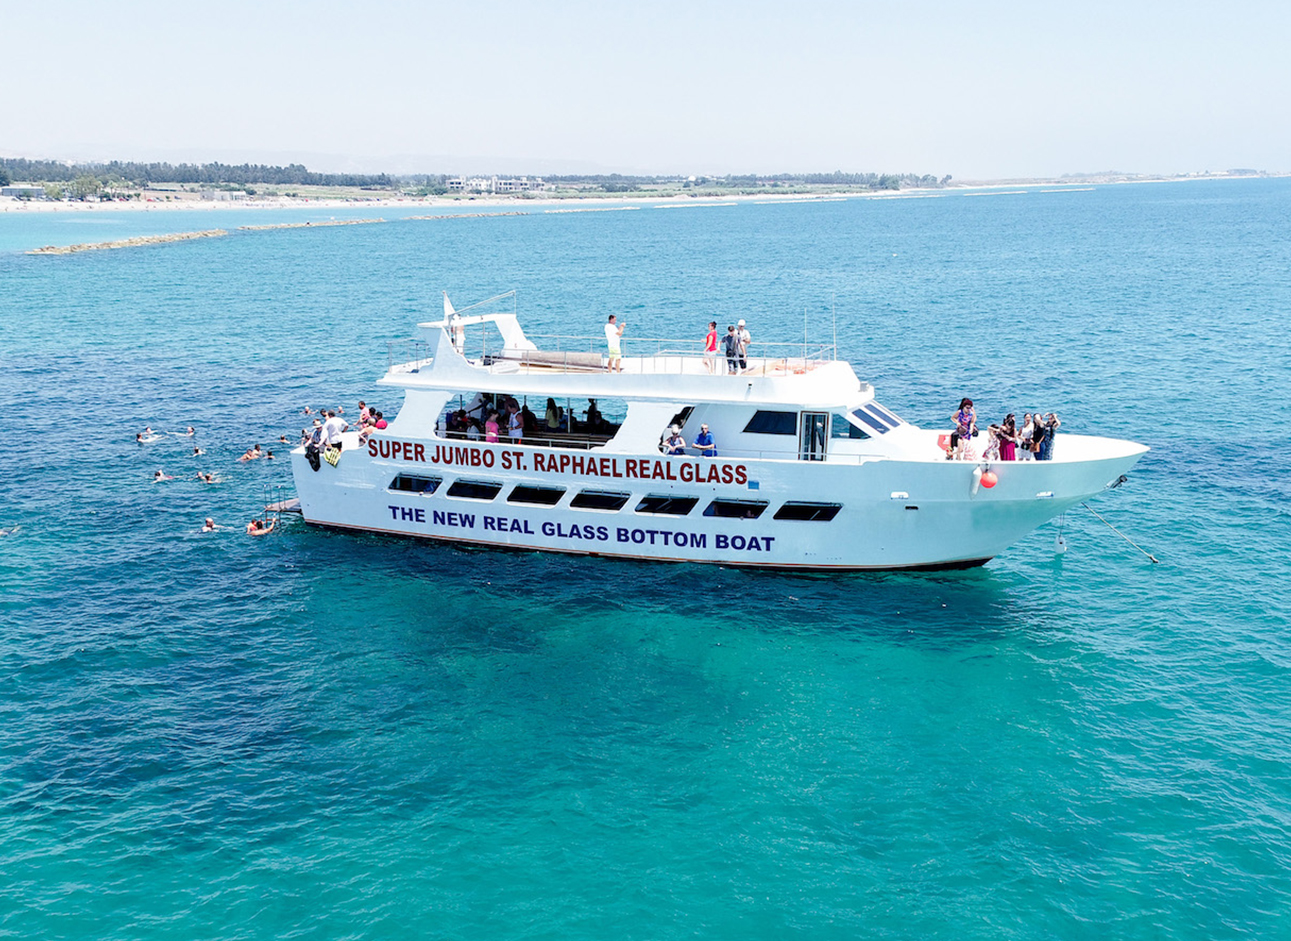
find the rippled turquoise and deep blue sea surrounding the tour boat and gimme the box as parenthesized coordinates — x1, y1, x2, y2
(0, 179, 1291, 941)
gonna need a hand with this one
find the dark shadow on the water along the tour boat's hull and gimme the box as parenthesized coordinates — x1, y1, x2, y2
(282, 516, 1061, 647)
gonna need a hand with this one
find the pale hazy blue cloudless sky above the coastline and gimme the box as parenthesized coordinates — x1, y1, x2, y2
(0, 0, 1291, 179)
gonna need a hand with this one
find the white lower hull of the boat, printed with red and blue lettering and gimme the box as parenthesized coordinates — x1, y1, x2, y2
(292, 435, 1146, 571)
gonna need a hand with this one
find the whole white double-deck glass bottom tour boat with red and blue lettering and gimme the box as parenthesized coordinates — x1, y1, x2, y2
(292, 296, 1148, 571)
